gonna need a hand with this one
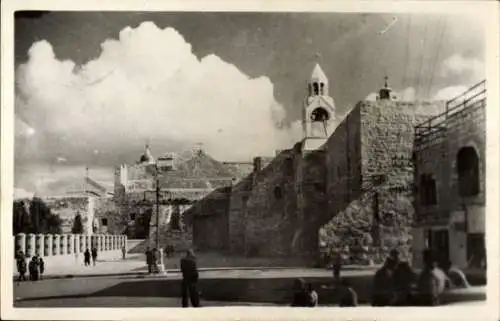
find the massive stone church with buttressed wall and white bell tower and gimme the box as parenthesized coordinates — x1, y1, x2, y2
(188, 65, 444, 264)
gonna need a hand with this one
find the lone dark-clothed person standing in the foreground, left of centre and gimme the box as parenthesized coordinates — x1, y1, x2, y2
(181, 250, 200, 308)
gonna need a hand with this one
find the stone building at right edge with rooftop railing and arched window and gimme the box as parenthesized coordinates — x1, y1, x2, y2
(413, 81, 486, 268)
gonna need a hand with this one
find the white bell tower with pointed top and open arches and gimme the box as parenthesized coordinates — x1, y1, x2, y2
(302, 64, 335, 150)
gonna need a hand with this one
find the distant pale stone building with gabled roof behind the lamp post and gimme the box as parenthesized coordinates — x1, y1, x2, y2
(113, 145, 251, 246)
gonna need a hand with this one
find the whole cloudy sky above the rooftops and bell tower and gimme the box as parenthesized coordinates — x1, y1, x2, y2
(15, 12, 485, 194)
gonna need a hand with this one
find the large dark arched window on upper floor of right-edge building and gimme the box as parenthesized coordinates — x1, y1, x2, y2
(457, 147, 479, 197)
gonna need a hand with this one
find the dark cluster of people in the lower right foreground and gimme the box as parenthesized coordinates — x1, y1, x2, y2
(291, 246, 469, 307)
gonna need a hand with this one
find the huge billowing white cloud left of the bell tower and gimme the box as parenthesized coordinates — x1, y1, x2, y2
(16, 22, 297, 164)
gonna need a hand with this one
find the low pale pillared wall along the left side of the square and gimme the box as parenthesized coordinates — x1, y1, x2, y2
(14, 233, 127, 267)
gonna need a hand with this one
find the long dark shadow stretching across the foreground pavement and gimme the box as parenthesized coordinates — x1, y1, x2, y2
(16, 275, 486, 305)
